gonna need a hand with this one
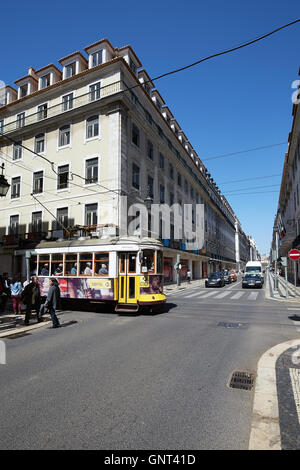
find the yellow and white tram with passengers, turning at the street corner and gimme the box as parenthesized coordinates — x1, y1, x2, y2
(30, 237, 166, 312)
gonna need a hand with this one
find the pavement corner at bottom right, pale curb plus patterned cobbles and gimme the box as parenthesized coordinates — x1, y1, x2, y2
(249, 340, 300, 450)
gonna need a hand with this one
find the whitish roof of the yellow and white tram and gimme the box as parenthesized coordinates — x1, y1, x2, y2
(35, 236, 163, 249)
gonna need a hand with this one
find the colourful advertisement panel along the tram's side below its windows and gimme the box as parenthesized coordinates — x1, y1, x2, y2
(39, 277, 114, 300)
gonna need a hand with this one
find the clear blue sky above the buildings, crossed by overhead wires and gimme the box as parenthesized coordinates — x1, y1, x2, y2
(0, 0, 300, 253)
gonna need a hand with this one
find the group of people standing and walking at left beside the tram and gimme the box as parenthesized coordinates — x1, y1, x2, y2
(0, 273, 60, 328)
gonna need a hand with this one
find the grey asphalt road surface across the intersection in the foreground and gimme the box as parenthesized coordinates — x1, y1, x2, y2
(0, 282, 299, 450)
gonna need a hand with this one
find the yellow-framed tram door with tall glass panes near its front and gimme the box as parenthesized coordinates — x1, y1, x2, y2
(119, 252, 138, 304)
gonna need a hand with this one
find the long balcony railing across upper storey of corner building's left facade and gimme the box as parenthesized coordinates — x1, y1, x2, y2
(0, 81, 126, 137)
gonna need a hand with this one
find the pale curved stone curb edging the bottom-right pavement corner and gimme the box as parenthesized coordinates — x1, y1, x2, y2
(249, 340, 300, 450)
